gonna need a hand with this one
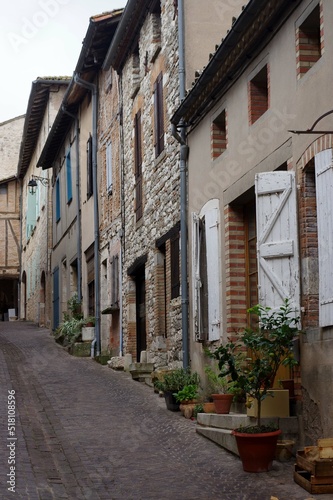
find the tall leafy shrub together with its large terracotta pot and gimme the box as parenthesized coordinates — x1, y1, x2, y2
(213, 299, 299, 472)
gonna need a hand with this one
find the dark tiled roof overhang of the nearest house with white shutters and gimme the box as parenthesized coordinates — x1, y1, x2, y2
(171, 0, 302, 128)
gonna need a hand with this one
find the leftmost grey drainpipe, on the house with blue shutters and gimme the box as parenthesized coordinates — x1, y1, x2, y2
(62, 106, 82, 302)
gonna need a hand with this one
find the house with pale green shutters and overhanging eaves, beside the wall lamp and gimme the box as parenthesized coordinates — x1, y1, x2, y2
(17, 77, 69, 327)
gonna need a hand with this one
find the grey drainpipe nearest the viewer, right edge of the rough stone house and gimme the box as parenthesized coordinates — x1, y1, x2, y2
(172, 0, 189, 368)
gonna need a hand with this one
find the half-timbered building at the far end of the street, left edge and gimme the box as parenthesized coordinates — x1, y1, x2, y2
(0, 116, 24, 321)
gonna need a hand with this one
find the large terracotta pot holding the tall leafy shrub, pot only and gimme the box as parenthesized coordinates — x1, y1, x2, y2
(232, 429, 281, 472)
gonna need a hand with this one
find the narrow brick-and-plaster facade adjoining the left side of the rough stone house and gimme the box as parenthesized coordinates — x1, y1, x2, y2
(98, 68, 123, 356)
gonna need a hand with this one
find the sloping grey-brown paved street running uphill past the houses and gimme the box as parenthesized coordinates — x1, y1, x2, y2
(0, 322, 327, 500)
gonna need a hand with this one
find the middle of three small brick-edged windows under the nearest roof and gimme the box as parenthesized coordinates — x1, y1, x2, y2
(248, 64, 269, 125)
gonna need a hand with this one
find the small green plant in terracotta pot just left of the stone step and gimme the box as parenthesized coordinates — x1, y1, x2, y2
(205, 365, 233, 414)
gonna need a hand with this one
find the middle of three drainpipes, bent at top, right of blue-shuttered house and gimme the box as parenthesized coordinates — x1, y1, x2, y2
(74, 73, 101, 357)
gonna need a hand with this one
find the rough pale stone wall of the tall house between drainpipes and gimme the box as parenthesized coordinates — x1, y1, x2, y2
(121, 1, 182, 366)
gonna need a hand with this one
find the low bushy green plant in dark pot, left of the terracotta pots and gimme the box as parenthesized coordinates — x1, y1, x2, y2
(154, 368, 200, 411)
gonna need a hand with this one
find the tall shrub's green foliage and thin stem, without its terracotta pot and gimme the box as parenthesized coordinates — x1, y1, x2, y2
(211, 299, 300, 430)
